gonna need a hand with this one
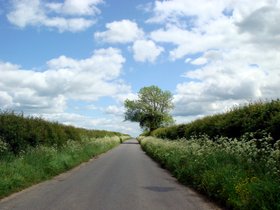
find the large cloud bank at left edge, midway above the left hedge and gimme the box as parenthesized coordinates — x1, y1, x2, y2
(0, 48, 130, 113)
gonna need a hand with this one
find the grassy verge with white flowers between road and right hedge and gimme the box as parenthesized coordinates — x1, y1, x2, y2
(139, 135, 280, 210)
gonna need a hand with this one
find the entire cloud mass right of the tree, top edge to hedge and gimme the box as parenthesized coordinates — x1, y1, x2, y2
(147, 0, 280, 122)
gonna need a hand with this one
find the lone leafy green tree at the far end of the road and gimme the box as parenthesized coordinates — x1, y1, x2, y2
(124, 85, 174, 132)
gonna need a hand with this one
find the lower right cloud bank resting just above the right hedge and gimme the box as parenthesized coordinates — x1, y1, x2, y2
(174, 48, 280, 121)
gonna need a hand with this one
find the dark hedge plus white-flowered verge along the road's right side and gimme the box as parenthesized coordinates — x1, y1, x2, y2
(141, 100, 280, 210)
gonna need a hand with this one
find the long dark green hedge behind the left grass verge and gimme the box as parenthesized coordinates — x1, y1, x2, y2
(0, 111, 128, 154)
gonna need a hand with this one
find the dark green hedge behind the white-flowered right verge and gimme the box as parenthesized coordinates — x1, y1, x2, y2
(151, 100, 280, 142)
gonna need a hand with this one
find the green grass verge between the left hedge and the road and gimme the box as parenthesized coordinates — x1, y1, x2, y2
(0, 136, 121, 198)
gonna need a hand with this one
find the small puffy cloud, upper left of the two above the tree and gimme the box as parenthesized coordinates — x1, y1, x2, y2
(94, 19, 144, 43)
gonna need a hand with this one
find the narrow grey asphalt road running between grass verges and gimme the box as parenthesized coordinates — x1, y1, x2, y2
(0, 140, 219, 210)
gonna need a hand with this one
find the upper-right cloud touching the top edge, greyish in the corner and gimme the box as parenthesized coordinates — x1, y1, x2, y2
(150, 0, 280, 60)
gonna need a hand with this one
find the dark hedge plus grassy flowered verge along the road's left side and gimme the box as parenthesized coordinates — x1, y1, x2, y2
(0, 111, 130, 198)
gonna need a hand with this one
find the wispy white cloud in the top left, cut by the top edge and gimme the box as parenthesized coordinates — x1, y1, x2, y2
(7, 0, 103, 32)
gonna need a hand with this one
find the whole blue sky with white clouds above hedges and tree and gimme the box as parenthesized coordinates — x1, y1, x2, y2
(0, 0, 280, 136)
